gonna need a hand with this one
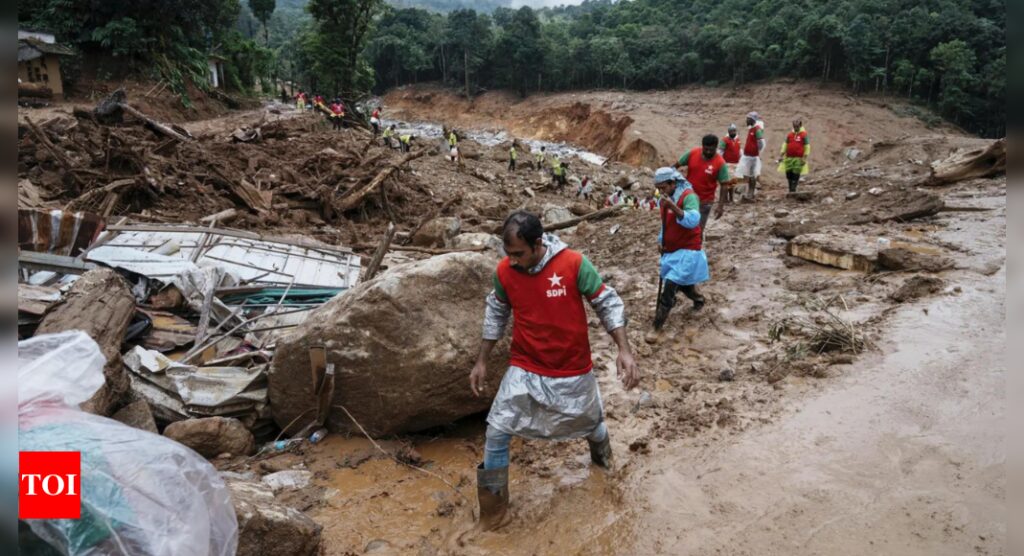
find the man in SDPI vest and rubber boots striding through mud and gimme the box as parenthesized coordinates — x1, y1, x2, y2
(469, 211, 640, 529)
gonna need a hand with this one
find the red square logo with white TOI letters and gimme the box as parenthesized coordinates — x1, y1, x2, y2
(17, 452, 82, 519)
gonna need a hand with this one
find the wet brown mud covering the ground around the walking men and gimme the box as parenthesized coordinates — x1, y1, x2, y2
(18, 85, 1006, 555)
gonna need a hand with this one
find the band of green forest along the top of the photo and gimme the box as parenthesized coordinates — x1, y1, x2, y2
(18, 0, 1007, 136)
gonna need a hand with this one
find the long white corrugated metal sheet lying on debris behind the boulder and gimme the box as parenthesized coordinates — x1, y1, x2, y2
(87, 229, 359, 289)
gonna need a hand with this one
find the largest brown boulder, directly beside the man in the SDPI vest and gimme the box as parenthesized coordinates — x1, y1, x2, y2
(269, 252, 508, 435)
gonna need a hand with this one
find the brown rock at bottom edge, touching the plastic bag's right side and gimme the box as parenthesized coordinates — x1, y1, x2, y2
(226, 479, 324, 556)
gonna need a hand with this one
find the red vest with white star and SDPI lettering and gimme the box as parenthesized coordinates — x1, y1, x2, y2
(498, 249, 604, 377)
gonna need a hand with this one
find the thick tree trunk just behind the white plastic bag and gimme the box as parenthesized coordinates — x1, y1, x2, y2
(36, 268, 135, 417)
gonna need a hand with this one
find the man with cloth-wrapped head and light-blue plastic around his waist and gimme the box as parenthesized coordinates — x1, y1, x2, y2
(644, 167, 717, 344)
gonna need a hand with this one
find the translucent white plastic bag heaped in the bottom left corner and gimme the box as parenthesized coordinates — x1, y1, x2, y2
(18, 332, 238, 556)
